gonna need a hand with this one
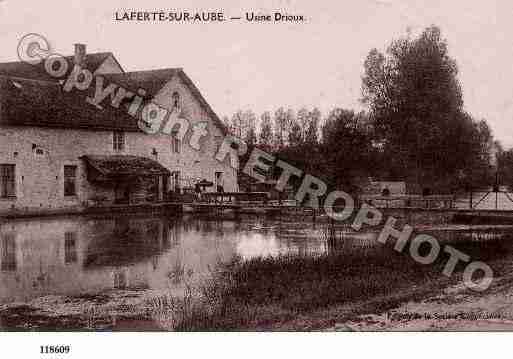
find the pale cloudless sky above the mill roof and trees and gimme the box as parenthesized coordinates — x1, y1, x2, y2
(0, 0, 513, 147)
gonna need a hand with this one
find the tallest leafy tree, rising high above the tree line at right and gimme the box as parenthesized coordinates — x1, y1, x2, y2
(362, 26, 484, 190)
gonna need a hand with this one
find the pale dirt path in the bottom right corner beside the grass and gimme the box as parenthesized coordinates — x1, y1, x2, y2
(336, 274, 513, 331)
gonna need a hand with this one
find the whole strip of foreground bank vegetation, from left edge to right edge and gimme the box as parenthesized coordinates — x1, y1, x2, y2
(0, 228, 513, 331)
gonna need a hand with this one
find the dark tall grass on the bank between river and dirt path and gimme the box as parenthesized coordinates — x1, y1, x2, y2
(149, 231, 511, 331)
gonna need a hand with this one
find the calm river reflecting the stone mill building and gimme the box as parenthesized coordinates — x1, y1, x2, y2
(0, 216, 512, 330)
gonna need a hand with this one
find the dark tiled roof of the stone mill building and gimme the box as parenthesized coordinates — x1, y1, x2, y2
(0, 62, 227, 134)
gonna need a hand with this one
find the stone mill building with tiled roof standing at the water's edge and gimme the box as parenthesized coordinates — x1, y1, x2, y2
(0, 44, 238, 210)
